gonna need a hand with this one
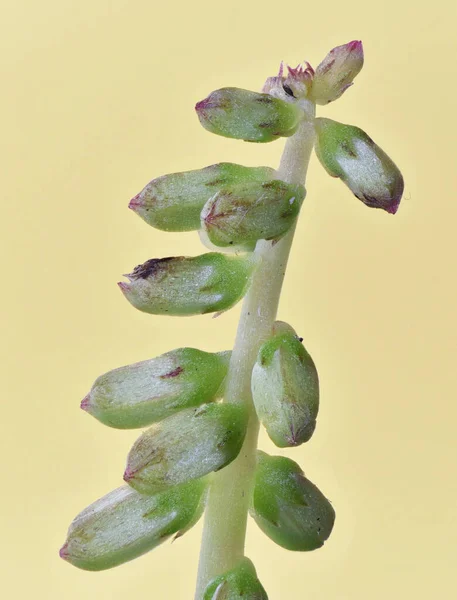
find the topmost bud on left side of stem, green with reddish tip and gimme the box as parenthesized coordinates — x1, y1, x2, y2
(195, 88, 302, 142)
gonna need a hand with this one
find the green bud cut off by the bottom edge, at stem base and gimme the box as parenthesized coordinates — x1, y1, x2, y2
(203, 558, 268, 600)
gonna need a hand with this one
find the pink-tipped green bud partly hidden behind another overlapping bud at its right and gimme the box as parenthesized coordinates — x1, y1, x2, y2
(129, 163, 275, 231)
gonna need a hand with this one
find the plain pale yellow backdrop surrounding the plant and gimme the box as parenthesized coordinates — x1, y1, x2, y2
(0, 0, 457, 600)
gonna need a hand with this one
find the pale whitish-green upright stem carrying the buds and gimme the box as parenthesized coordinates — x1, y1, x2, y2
(195, 110, 314, 600)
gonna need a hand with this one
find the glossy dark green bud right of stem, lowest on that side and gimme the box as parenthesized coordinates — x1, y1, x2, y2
(250, 452, 335, 551)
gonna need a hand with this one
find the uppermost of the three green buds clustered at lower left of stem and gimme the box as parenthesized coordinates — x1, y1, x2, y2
(81, 348, 230, 429)
